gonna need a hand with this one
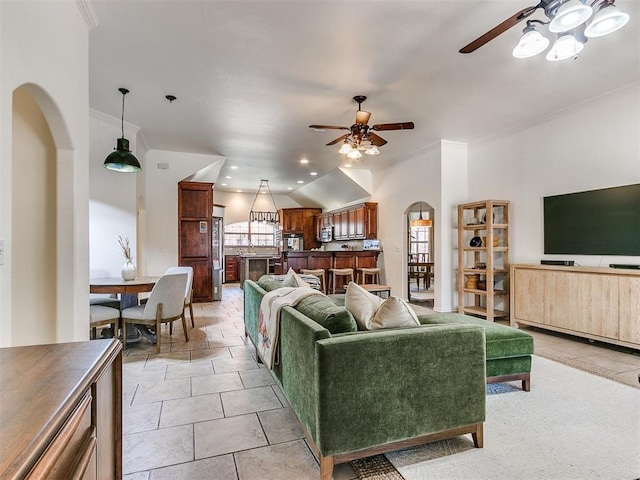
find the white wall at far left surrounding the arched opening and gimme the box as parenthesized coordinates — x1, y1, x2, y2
(0, 1, 89, 346)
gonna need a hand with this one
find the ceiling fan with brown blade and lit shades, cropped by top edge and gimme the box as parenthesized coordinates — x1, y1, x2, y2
(459, 0, 629, 61)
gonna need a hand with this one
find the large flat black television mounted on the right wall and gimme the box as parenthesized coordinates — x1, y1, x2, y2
(543, 184, 640, 256)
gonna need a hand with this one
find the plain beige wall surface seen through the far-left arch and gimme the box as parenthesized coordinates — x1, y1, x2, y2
(11, 88, 57, 345)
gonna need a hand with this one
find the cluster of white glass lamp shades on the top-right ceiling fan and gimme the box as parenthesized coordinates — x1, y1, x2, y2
(513, 0, 629, 62)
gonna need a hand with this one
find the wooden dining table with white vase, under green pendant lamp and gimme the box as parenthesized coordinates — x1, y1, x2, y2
(89, 276, 160, 343)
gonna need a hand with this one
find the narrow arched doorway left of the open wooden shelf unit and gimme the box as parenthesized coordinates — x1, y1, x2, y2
(407, 201, 434, 307)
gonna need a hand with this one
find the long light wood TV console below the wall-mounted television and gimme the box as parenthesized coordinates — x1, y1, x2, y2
(510, 264, 640, 349)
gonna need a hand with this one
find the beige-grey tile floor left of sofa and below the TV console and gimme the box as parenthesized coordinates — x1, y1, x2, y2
(123, 284, 640, 480)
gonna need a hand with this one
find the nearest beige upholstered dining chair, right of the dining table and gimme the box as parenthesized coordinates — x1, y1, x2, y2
(122, 273, 189, 353)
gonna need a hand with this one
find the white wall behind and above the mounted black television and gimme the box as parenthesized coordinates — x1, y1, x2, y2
(469, 85, 640, 266)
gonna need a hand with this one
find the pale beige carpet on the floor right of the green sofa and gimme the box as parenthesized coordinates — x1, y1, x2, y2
(387, 356, 640, 480)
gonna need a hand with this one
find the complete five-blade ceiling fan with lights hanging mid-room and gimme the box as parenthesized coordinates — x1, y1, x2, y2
(309, 95, 414, 159)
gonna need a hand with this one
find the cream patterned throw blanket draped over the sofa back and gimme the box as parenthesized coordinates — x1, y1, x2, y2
(256, 287, 323, 369)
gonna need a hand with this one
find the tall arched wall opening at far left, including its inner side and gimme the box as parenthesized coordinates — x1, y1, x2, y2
(9, 84, 75, 345)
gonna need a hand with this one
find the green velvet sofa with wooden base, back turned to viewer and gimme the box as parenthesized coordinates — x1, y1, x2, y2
(243, 277, 486, 480)
